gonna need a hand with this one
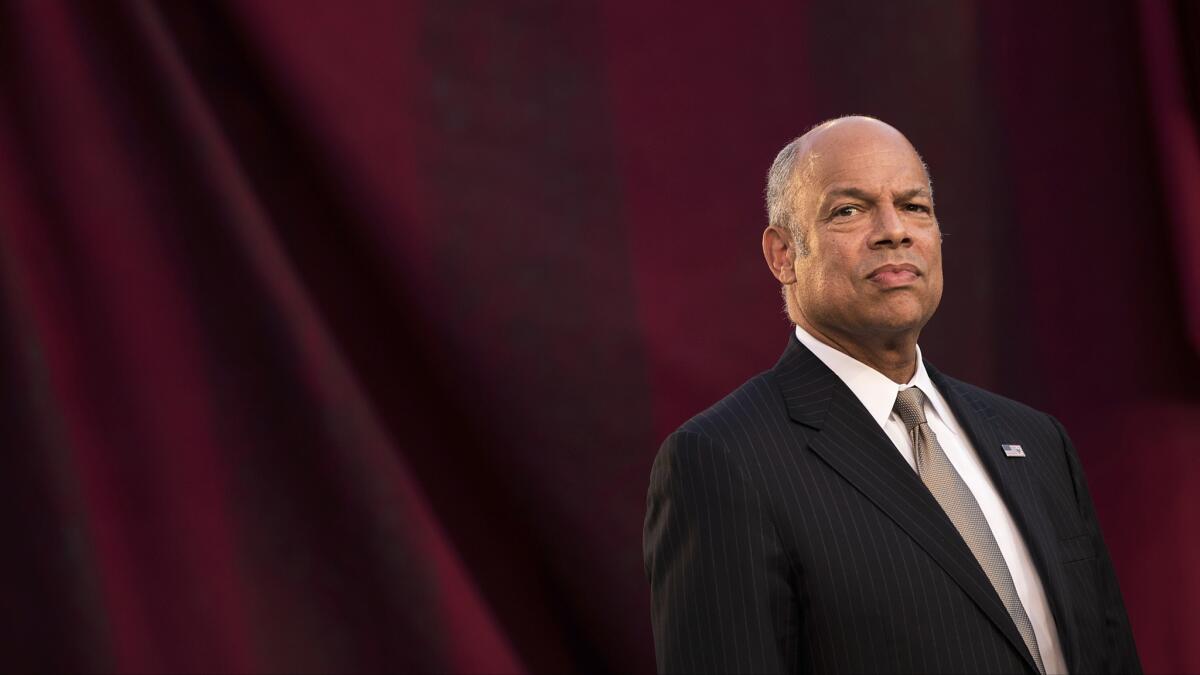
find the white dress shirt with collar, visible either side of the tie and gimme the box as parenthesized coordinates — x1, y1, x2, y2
(796, 325, 1067, 674)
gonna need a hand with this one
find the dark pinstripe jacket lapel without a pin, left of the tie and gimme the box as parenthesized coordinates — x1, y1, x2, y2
(774, 338, 1037, 673)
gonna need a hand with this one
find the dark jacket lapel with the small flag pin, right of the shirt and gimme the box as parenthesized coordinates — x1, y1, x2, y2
(925, 362, 1079, 673)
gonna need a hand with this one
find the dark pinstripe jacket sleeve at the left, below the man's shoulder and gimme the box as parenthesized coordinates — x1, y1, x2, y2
(643, 431, 798, 673)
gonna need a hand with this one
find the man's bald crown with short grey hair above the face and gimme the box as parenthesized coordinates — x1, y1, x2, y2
(767, 115, 932, 239)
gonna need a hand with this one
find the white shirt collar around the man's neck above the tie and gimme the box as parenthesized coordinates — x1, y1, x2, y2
(796, 325, 952, 426)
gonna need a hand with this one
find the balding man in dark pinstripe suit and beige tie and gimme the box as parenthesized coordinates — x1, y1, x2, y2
(643, 118, 1141, 675)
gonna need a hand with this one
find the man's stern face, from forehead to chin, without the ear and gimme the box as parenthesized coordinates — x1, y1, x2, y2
(790, 124, 942, 338)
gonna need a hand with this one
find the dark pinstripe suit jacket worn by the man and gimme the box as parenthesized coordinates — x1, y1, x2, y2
(643, 338, 1141, 675)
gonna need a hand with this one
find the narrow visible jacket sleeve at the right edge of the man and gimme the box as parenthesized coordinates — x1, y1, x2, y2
(1050, 417, 1141, 674)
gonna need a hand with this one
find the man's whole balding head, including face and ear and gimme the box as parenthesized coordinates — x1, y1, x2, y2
(762, 117, 942, 353)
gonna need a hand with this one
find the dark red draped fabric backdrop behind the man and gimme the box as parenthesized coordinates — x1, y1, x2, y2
(0, 0, 1200, 673)
